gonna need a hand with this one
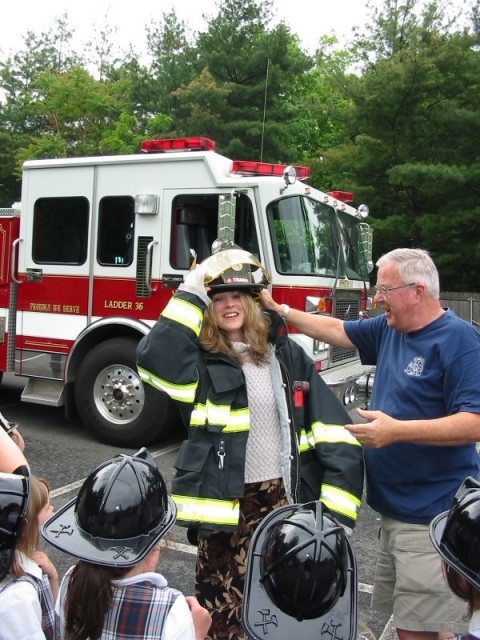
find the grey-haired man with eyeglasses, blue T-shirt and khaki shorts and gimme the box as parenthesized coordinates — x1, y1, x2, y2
(261, 249, 480, 640)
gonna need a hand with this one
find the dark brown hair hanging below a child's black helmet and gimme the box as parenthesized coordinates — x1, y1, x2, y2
(65, 560, 130, 640)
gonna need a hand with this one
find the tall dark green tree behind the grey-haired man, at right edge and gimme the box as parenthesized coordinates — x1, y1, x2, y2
(322, 0, 480, 289)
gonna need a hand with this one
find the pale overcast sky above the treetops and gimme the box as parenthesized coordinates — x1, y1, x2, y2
(0, 0, 382, 59)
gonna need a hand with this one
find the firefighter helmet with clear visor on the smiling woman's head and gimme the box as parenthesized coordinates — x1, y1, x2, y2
(201, 247, 272, 295)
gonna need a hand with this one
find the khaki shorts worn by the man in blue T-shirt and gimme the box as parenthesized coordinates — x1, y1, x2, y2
(372, 516, 468, 634)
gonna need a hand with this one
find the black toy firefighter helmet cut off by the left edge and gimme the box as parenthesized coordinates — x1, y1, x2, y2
(0, 467, 30, 580)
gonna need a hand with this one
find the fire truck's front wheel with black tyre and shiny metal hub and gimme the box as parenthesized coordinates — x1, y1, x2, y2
(75, 338, 172, 447)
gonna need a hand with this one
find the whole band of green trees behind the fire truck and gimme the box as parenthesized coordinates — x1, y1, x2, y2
(0, 0, 480, 289)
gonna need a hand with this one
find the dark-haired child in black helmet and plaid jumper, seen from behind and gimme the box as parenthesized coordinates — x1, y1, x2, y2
(42, 449, 211, 640)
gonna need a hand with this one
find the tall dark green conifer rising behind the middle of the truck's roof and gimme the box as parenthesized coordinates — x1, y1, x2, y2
(177, 0, 312, 162)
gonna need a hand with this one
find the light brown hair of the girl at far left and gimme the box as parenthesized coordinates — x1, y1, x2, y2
(10, 476, 49, 578)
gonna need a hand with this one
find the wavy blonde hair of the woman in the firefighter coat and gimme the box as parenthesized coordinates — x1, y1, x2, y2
(200, 289, 270, 365)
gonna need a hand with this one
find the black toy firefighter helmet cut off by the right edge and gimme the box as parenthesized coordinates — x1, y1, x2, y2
(430, 476, 480, 590)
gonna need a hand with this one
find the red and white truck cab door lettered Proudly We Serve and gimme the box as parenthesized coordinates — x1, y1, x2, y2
(16, 161, 94, 380)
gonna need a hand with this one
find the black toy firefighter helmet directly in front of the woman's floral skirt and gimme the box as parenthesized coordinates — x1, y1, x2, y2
(243, 501, 357, 640)
